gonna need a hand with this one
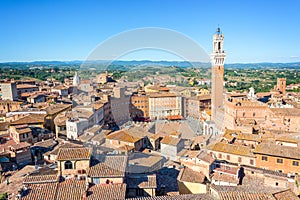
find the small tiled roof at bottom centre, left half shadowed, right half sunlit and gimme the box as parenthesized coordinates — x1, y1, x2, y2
(126, 174, 157, 188)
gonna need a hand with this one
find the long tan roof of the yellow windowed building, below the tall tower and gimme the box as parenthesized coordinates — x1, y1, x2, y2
(207, 142, 254, 157)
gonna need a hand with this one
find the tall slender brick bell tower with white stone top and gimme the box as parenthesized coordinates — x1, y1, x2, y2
(210, 28, 226, 120)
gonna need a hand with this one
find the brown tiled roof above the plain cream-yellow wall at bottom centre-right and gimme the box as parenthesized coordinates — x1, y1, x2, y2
(177, 167, 206, 183)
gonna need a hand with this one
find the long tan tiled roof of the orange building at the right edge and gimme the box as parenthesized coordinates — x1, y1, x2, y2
(253, 143, 300, 160)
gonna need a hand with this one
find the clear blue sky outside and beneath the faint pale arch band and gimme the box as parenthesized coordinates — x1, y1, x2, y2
(0, 0, 300, 63)
